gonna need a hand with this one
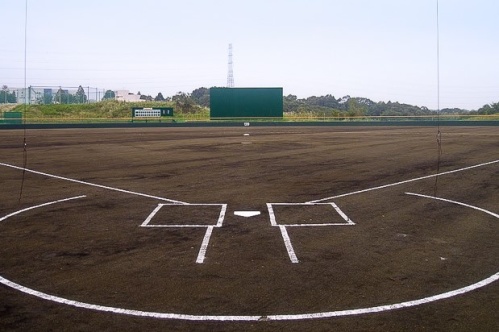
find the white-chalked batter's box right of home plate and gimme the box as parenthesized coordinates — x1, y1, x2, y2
(267, 203, 355, 227)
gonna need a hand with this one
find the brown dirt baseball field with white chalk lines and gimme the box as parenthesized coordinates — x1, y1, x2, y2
(0, 126, 499, 331)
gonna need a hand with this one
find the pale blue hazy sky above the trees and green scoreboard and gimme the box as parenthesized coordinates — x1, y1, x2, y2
(0, 0, 499, 110)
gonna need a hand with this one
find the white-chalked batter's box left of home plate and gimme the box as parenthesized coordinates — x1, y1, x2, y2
(141, 204, 227, 228)
